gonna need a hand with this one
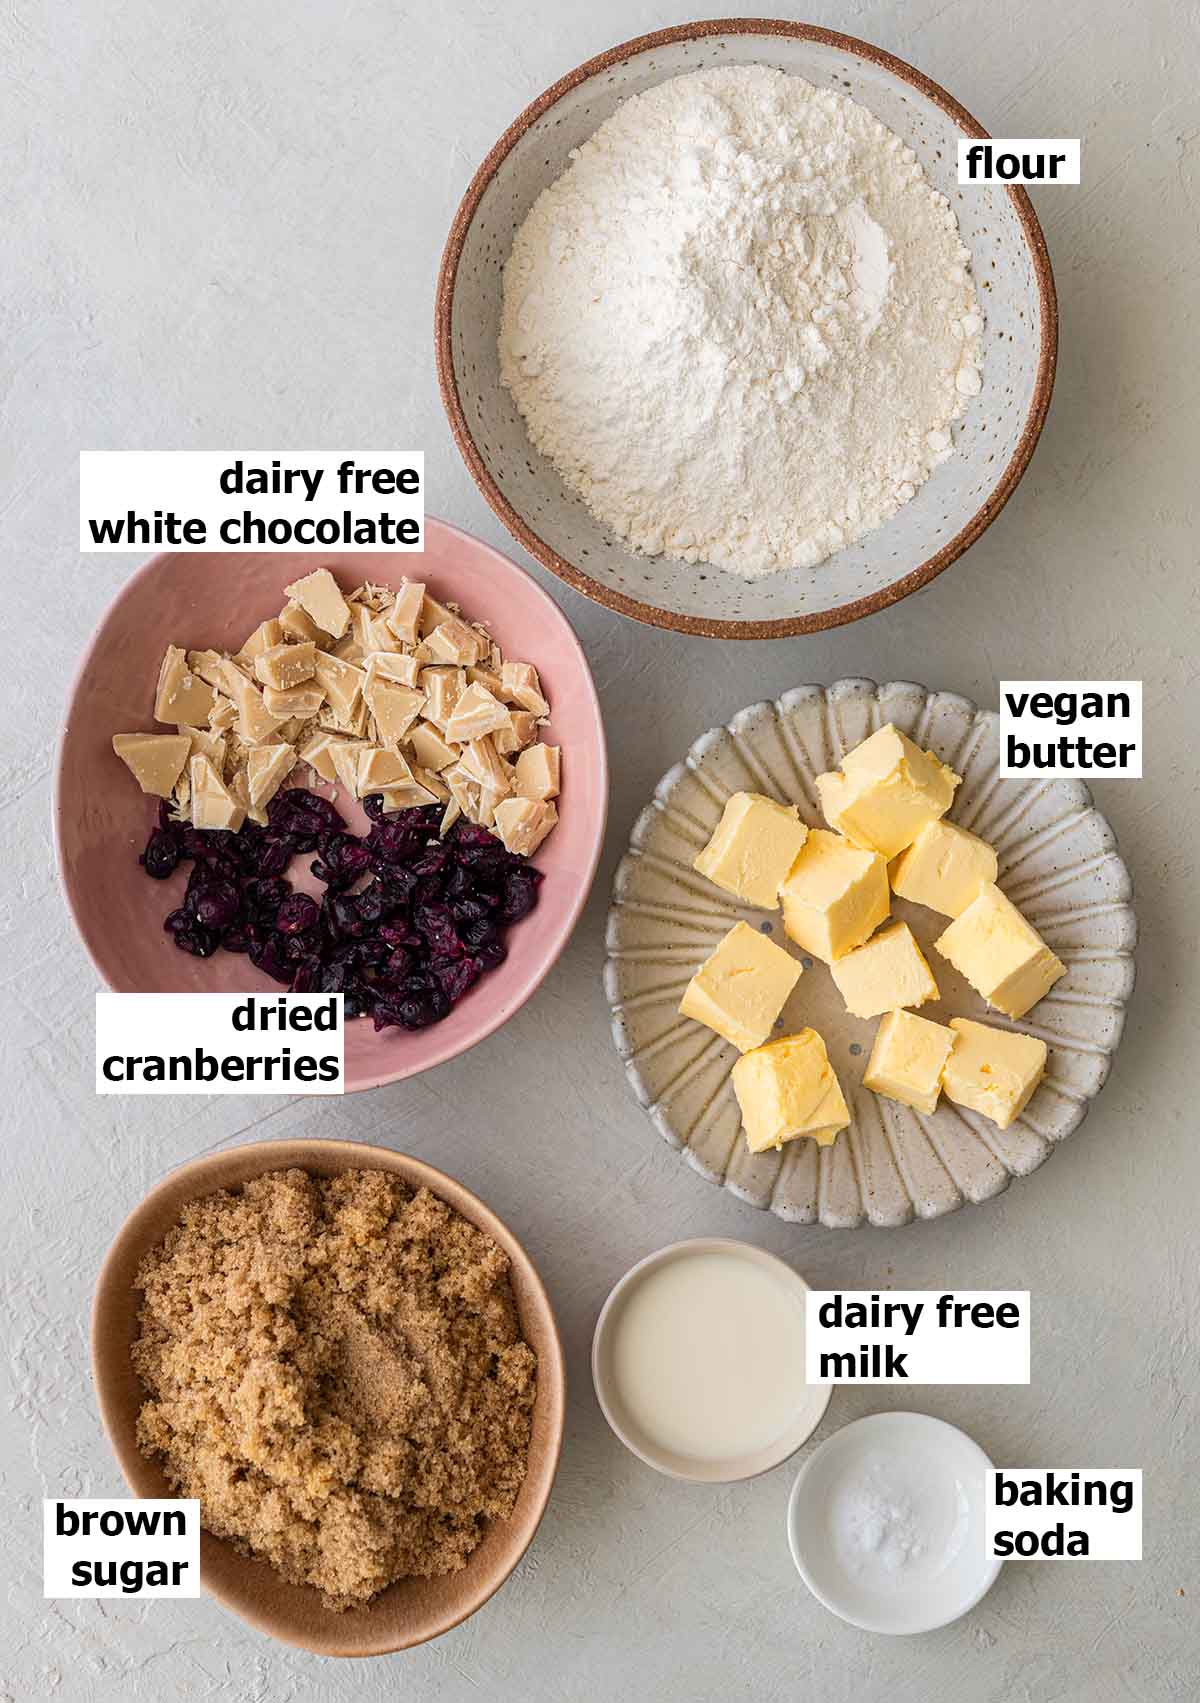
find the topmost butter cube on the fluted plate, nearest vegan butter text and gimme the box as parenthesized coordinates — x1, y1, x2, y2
(817, 722, 960, 858)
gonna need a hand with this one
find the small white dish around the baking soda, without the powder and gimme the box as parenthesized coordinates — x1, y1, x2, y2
(788, 1413, 1001, 1633)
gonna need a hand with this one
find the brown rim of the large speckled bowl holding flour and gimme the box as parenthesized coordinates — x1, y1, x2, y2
(434, 17, 1059, 639)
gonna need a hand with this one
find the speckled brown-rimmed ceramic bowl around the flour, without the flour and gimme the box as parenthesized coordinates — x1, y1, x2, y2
(436, 19, 1057, 639)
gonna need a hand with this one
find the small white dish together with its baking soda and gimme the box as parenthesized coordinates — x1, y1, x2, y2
(788, 1413, 1001, 1633)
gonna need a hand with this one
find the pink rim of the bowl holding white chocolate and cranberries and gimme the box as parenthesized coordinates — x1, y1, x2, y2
(49, 513, 609, 1093)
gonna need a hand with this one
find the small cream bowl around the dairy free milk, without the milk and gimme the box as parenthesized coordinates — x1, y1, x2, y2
(592, 1236, 831, 1483)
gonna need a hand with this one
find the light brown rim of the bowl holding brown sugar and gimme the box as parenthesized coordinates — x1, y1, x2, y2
(89, 1138, 567, 1657)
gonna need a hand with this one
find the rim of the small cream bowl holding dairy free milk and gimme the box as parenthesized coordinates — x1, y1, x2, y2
(591, 1236, 834, 1485)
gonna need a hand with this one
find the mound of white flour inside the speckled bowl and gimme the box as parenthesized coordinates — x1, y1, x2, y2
(500, 66, 982, 579)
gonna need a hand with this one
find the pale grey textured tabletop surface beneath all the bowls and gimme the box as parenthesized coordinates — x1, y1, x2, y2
(0, 0, 1200, 1703)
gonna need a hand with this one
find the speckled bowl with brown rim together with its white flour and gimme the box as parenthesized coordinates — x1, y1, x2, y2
(437, 20, 1057, 639)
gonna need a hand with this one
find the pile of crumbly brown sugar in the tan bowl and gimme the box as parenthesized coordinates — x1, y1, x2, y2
(133, 1170, 536, 1609)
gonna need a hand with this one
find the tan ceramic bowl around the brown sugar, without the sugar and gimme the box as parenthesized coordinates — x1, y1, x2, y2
(92, 1141, 567, 1655)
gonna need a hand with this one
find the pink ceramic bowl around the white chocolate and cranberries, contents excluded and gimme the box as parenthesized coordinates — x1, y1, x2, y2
(54, 519, 608, 1092)
